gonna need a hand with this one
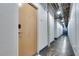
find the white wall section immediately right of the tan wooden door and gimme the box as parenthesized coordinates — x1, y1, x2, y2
(34, 3, 48, 52)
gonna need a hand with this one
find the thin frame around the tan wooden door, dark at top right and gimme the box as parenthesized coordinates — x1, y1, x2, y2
(17, 3, 38, 56)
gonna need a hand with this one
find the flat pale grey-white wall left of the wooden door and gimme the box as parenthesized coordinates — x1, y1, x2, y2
(0, 3, 18, 56)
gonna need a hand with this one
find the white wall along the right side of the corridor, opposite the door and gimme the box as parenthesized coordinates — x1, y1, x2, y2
(68, 4, 79, 56)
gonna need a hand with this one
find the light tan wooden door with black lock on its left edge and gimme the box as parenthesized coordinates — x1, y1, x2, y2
(19, 3, 37, 56)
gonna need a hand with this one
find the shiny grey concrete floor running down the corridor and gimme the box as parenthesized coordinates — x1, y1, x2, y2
(40, 35, 75, 56)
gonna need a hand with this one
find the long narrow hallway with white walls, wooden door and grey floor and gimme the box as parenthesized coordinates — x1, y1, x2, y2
(0, 3, 79, 56)
